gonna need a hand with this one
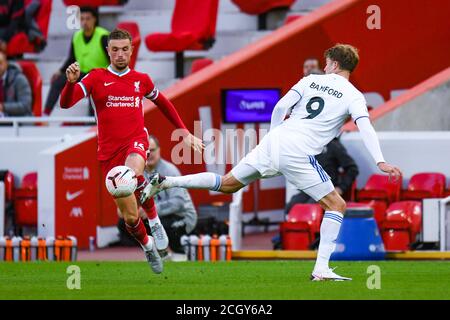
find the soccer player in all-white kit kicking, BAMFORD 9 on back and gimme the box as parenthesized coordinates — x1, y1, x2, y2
(143, 44, 402, 281)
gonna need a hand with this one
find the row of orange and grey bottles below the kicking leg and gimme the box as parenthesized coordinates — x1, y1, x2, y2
(180, 234, 232, 262)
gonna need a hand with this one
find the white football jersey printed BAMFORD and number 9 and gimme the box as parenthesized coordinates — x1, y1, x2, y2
(280, 73, 369, 155)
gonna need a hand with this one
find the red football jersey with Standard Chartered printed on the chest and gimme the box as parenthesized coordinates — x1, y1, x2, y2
(78, 66, 159, 160)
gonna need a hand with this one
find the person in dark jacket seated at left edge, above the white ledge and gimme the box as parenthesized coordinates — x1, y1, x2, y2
(0, 51, 33, 117)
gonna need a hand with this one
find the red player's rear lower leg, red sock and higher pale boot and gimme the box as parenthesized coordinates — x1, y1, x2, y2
(134, 175, 169, 257)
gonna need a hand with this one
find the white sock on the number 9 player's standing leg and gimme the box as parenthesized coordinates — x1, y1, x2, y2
(314, 211, 344, 271)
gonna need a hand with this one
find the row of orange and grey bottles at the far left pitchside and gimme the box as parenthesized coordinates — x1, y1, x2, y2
(0, 236, 78, 262)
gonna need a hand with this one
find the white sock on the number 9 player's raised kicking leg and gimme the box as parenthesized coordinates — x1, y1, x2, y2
(162, 172, 222, 191)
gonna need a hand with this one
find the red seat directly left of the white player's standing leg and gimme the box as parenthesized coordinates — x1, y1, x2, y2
(280, 204, 323, 250)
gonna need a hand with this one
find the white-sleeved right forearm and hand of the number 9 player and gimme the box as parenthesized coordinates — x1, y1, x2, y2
(355, 117, 402, 179)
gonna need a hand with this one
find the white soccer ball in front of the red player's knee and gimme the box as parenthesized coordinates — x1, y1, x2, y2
(105, 166, 137, 198)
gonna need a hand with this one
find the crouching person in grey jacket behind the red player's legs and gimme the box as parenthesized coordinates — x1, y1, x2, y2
(119, 135, 197, 261)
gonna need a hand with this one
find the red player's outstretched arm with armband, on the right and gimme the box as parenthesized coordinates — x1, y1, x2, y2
(146, 88, 205, 151)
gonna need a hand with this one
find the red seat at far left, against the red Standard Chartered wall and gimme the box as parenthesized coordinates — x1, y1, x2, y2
(14, 172, 37, 227)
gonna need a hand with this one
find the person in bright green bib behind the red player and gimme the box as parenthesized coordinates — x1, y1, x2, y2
(44, 7, 109, 115)
